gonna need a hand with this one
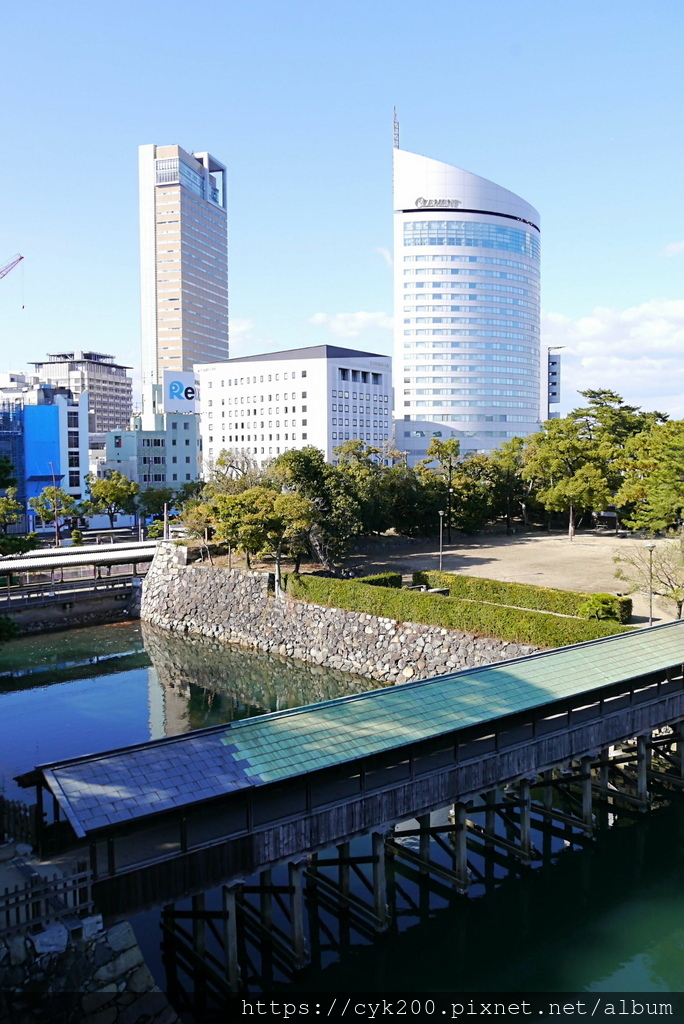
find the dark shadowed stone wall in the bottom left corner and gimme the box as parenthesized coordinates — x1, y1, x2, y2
(0, 918, 180, 1024)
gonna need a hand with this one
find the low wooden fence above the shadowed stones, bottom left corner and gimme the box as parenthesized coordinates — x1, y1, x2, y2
(0, 861, 93, 937)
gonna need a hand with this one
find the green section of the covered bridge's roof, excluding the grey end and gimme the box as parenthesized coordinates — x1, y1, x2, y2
(222, 622, 684, 783)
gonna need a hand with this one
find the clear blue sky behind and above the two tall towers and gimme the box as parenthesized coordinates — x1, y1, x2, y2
(0, 0, 684, 416)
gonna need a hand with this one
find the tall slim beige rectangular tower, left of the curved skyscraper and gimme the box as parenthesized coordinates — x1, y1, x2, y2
(139, 145, 228, 386)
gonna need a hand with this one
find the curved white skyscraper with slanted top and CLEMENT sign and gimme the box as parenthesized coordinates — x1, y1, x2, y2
(394, 148, 540, 462)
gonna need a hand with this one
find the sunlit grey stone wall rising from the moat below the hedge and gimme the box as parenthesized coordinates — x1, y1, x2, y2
(140, 544, 536, 683)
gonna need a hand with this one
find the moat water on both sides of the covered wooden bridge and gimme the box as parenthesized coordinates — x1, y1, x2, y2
(0, 624, 684, 992)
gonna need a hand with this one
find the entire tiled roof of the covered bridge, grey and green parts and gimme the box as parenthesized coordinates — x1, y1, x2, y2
(30, 622, 684, 836)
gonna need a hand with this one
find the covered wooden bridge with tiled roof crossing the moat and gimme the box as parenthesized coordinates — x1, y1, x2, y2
(14, 622, 684, 912)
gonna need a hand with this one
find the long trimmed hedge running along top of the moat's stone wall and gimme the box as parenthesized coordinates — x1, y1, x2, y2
(286, 574, 628, 647)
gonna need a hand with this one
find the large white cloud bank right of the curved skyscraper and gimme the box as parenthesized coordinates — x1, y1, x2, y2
(542, 299, 684, 419)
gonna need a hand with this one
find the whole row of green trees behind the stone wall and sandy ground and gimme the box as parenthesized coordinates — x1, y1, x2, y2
(176, 389, 684, 570)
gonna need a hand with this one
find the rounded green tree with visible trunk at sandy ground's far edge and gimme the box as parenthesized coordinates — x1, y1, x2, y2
(522, 417, 611, 541)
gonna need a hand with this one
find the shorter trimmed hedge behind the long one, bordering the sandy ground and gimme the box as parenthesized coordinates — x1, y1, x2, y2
(414, 571, 632, 625)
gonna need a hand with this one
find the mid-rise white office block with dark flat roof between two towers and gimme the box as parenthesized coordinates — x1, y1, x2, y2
(195, 345, 392, 475)
